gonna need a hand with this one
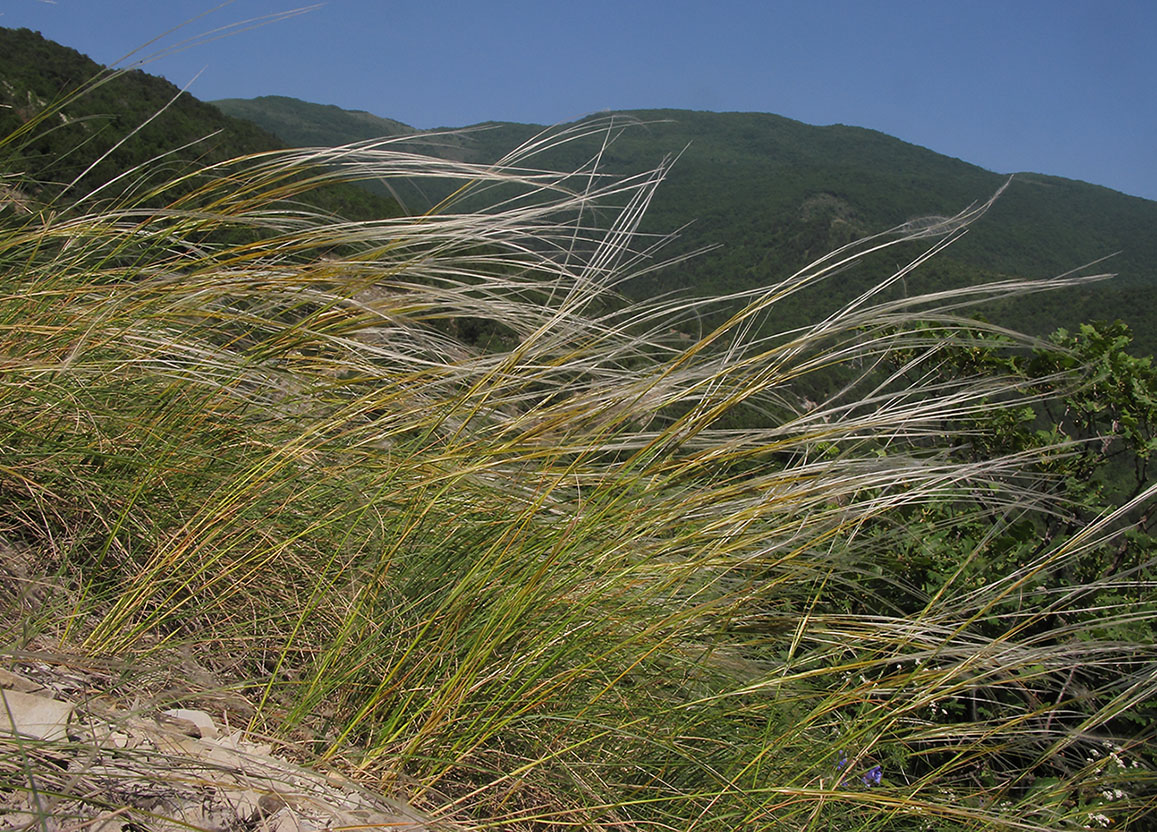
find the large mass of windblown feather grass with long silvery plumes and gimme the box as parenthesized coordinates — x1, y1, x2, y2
(0, 99, 1155, 830)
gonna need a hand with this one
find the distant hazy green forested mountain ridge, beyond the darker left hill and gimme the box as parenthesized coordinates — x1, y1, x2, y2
(215, 96, 1157, 352)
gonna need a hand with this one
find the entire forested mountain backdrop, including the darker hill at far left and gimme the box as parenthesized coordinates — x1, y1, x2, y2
(0, 29, 1157, 352)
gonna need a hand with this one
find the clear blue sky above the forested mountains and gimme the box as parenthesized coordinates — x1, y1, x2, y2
(0, 0, 1157, 199)
